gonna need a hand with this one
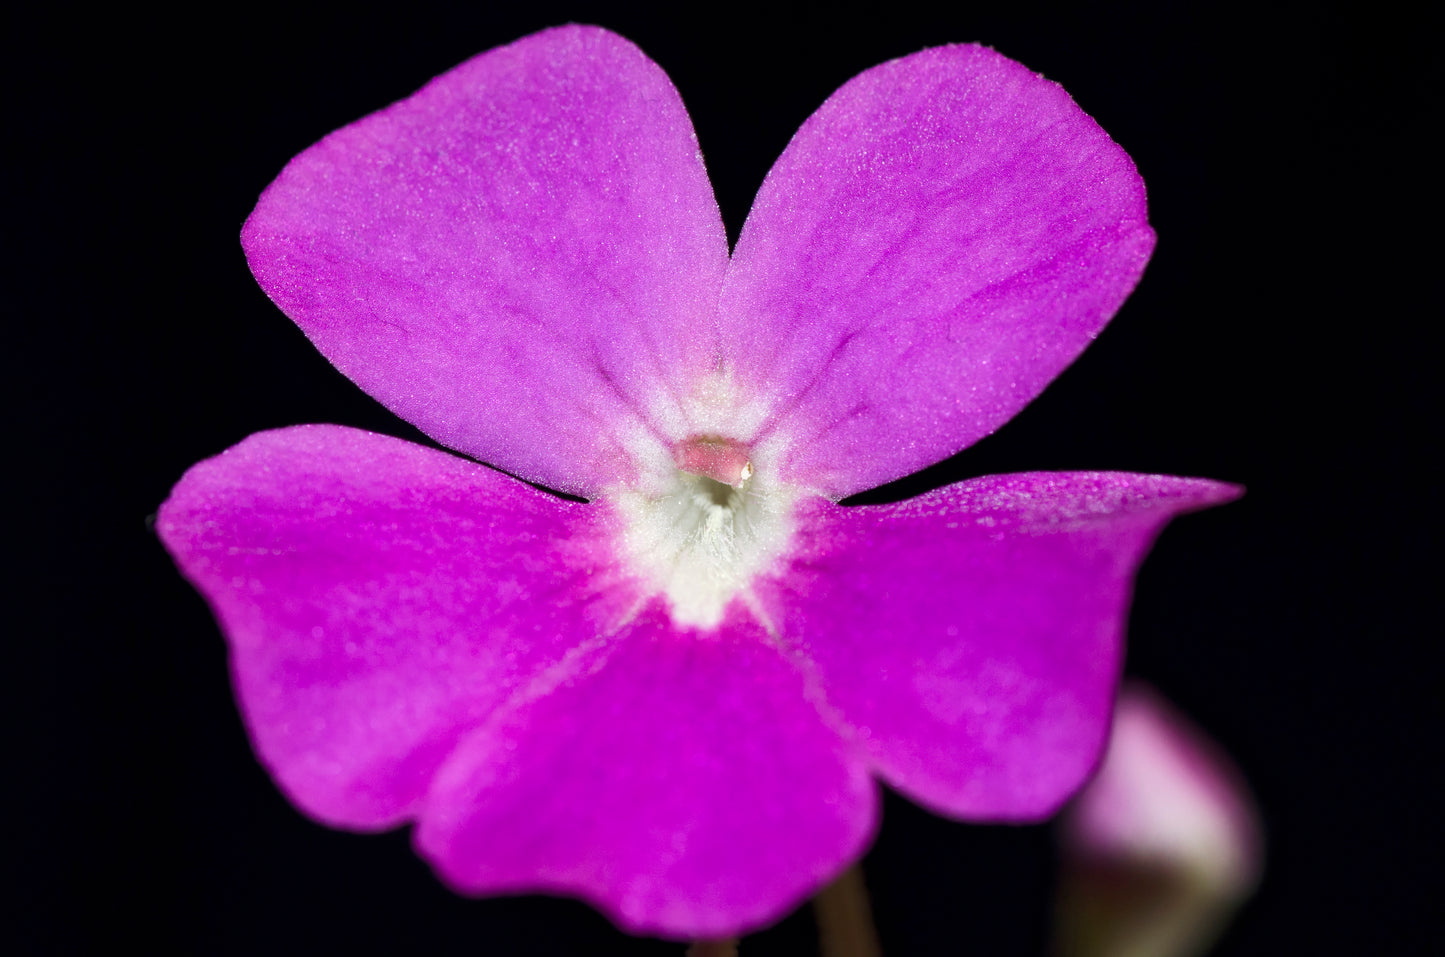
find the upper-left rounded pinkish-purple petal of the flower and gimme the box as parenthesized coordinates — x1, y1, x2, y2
(241, 26, 727, 494)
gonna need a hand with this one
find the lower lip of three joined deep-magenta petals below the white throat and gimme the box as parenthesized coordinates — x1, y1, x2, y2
(158, 426, 1238, 938)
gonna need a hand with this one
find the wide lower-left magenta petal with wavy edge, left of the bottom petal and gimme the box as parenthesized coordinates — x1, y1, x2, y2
(156, 425, 636, 828)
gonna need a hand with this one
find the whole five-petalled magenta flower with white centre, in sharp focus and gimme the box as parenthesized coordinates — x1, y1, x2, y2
(158, 26, 1237, 937)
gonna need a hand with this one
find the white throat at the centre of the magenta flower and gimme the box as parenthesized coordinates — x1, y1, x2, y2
(617, 435, 796, 629)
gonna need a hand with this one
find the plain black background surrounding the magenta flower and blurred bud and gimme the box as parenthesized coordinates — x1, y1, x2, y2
(8, 1, 1442, 957)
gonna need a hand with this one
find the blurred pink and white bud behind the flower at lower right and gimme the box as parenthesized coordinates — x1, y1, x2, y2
(1055, 684, 1264, 957)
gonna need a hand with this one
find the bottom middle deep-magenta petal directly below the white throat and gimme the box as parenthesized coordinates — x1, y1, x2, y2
(416, 611, 877, 938)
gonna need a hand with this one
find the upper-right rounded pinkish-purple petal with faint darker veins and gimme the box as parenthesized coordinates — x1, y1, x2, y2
(721, 46, 1155, 499)
